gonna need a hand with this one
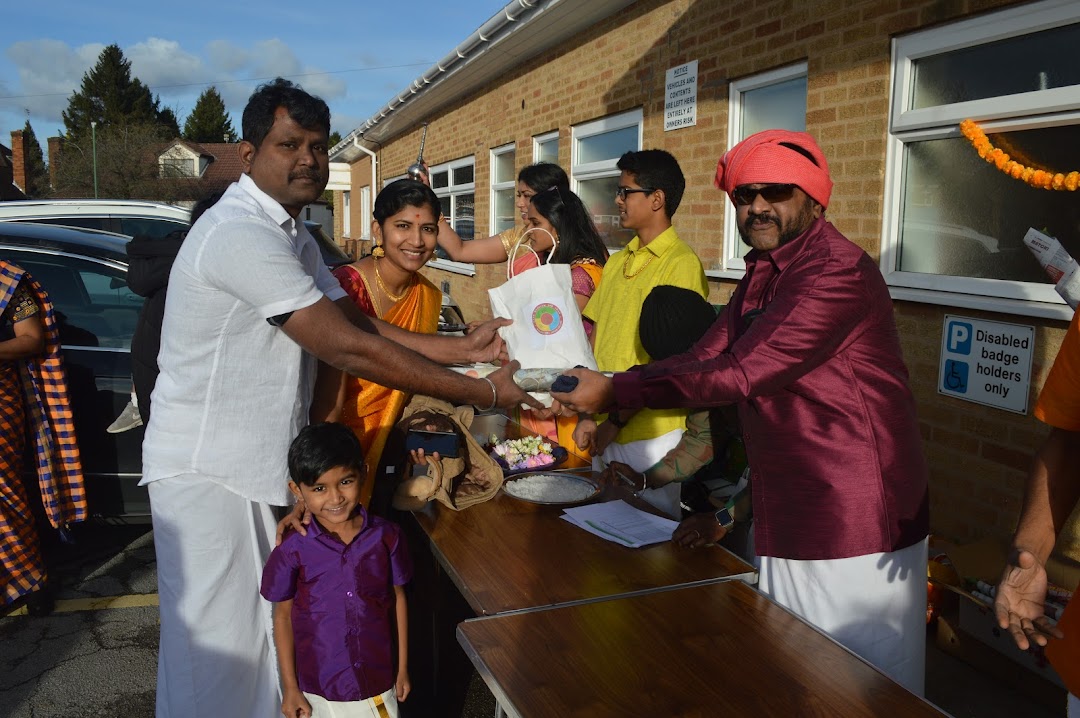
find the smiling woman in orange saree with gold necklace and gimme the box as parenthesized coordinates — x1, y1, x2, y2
(311, 179, 443, 507)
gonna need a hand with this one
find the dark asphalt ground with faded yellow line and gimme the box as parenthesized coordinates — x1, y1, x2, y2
(0, 521, 1065, 718)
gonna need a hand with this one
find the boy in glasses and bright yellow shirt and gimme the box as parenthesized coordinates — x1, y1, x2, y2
(575, 150, 708, 518)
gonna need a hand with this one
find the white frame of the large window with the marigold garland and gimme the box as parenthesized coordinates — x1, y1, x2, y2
(880, 0, 1080, 320)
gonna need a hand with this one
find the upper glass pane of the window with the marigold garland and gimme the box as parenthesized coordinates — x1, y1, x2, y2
(910, 24, 1080, 109)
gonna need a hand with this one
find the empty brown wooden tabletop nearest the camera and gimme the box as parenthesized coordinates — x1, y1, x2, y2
(458, 581, 946, 718)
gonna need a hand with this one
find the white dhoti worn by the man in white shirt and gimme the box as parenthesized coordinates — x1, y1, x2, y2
(148, 474, 281, 718)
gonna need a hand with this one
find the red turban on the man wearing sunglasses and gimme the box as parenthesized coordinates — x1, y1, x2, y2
(715, 130, 833, 207)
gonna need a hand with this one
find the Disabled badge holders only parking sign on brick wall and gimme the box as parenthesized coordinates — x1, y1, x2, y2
(937, 314, 1035, 414)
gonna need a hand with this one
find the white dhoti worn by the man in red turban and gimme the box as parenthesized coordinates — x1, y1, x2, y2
(757, 539, 927, 695)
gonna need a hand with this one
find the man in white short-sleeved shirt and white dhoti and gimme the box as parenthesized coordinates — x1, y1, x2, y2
(143, 78, 534, 718)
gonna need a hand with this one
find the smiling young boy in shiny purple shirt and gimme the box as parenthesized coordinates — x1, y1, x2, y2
(261, 423, 413, 718)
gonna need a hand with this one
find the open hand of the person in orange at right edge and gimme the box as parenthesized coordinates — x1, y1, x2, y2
(994, 548, 1062, 651)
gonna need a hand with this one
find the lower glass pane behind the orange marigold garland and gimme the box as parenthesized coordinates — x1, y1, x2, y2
(897, 125, 1080, 284)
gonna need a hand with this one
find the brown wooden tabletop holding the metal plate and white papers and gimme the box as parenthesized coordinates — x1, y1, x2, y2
(415, 479, 754, 615)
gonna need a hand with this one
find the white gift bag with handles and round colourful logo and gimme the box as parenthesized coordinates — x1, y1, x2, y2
(487, 228, 596, 369)
